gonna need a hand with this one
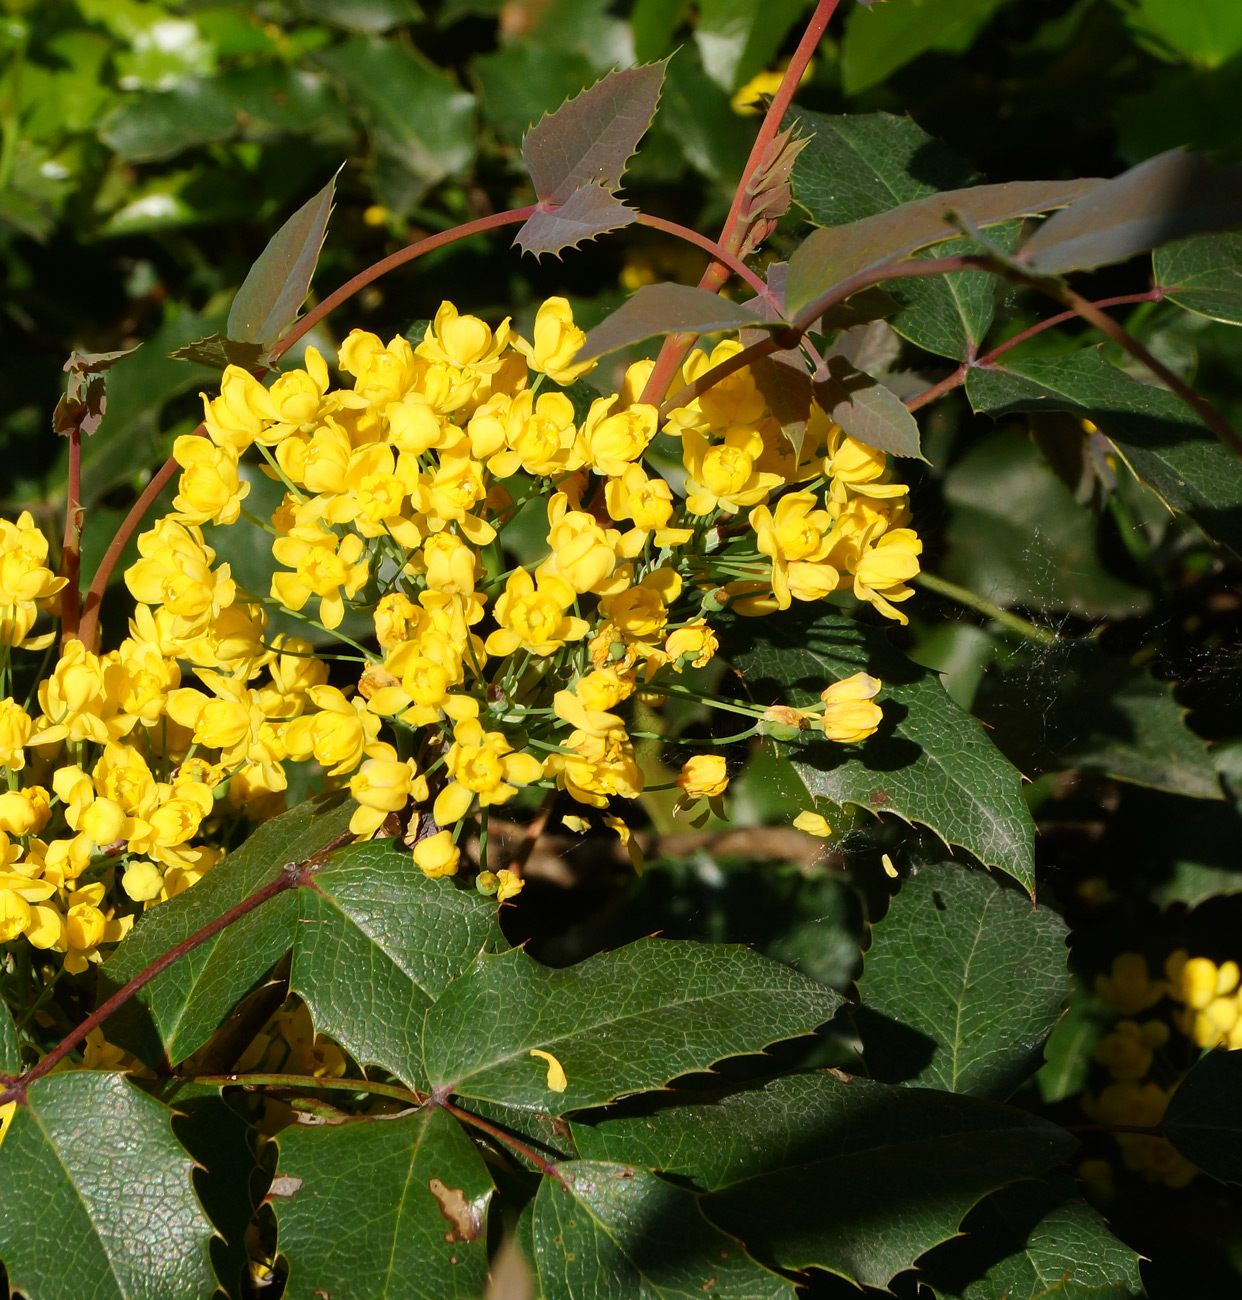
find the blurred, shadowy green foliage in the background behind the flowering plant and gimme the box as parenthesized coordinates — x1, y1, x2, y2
(7, 0, 1242, 1297)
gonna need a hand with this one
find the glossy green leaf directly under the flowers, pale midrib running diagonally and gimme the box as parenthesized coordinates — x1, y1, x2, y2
(289, 840, 506, 1087)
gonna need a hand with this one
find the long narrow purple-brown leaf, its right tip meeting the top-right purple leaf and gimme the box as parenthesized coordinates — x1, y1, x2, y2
(786, 178, 1107, 317)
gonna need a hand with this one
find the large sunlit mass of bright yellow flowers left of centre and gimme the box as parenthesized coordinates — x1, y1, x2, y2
(0, 289, 920, 972)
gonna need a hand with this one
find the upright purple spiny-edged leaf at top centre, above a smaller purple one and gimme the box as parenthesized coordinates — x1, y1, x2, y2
(522, 62, 665, 204)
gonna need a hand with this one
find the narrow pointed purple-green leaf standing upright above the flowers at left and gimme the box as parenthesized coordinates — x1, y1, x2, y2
(225, 177, 337, 345)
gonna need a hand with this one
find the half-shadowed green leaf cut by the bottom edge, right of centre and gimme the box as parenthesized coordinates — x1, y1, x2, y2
(918, 1175, 1143, 1300)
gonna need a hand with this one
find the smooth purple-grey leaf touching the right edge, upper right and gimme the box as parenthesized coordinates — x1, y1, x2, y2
(1017, 150, 1242, 276)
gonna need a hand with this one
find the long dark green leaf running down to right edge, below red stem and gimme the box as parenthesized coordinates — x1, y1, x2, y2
(966, 348, 1242, 553)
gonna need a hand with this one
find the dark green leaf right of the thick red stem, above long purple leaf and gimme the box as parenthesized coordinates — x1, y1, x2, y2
(784, 108, 971, 226)
